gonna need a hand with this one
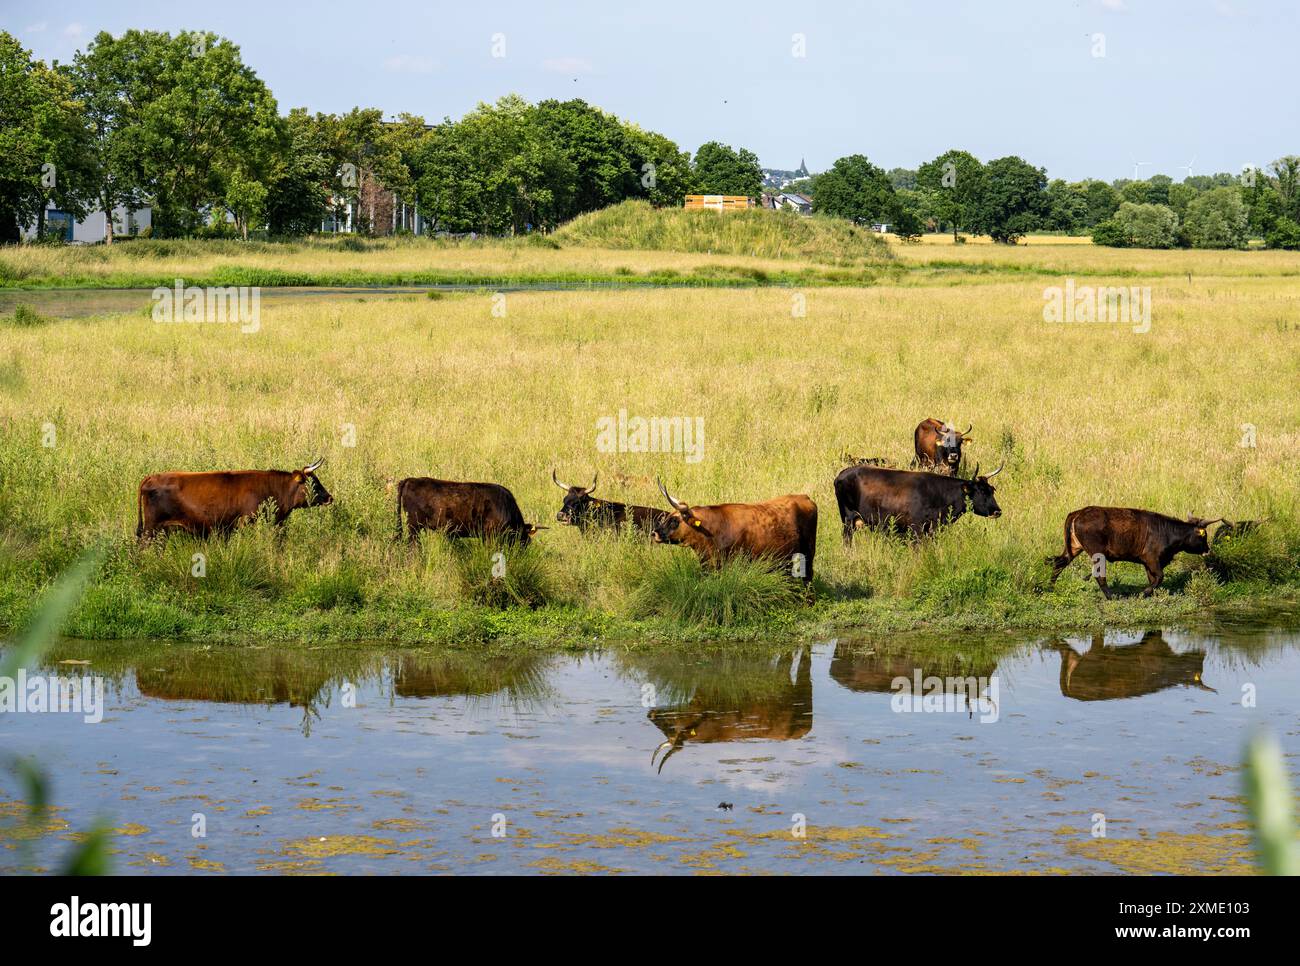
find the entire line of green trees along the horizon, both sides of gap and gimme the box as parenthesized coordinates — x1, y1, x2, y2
(0, 30, 1300, 248)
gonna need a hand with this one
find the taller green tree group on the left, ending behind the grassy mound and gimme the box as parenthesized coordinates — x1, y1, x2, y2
(0, 30, 762, 242)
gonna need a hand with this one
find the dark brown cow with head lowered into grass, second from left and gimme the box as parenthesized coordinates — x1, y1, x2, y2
(398, 476, 546, 545)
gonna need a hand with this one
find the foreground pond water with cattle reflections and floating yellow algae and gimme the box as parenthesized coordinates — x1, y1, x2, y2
(0, 623, 1300, 874)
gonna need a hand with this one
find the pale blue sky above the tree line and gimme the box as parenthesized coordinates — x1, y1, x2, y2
(0, 0, 1300, 181)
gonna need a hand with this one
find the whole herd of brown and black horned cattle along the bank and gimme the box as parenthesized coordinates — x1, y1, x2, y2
(135, 419, 1243, 597)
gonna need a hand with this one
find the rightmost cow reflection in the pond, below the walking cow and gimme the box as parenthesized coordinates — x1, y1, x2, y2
(1056, 631, 1217, 701)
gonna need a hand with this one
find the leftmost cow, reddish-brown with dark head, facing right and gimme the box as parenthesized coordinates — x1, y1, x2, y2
(135, 460, 334, 540)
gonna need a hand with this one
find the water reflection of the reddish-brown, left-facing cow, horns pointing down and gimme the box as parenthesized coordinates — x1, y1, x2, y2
(649, 650, 813, 772)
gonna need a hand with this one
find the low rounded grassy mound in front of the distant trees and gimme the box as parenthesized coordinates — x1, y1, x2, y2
(553, 202, 893, 264)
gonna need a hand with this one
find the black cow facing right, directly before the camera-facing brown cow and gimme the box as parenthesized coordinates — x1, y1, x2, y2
(835, 467, 1002, 545)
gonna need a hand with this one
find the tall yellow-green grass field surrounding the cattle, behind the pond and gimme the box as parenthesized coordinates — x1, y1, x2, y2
(0, 257, 1300, 642)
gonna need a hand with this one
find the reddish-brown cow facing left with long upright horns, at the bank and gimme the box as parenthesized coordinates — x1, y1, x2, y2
(654, 481, 816, 581)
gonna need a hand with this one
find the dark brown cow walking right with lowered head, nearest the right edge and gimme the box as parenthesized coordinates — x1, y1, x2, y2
(1052, 507, 1218, 598)
